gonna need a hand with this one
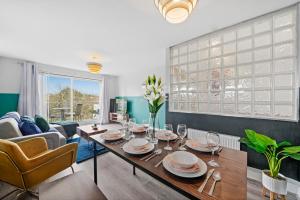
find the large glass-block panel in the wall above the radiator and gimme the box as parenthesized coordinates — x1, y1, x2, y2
(169, 7, 298, 120)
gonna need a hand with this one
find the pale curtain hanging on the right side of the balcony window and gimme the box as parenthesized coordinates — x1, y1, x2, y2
(100, 75, 118, 124)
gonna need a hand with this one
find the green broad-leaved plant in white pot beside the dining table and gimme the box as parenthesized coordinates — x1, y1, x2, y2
(240, 129, 300, 195)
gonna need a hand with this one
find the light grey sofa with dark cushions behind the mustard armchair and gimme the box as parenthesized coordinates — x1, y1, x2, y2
(0, 113, 66, 149)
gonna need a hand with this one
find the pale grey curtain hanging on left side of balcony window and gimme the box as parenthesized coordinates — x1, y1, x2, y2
(18, 62, 41, 116)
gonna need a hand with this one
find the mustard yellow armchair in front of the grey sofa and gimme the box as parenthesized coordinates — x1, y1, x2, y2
(0, 137, 77, 191)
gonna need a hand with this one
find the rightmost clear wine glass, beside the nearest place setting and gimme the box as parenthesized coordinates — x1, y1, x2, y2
(206, 131, 220, 167)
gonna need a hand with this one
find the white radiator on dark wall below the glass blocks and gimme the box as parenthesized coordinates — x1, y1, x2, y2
(188, 128, 240, 150)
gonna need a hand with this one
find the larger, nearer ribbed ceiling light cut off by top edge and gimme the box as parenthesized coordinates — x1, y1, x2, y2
(154, 0, 197, 24)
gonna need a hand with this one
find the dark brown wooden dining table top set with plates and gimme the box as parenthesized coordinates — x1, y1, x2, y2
(90, 134, 247, 200)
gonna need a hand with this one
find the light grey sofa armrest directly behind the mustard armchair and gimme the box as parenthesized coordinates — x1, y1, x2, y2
(9, 132, 66, 149)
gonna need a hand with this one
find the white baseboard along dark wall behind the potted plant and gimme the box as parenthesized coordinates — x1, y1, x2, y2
(247, 167, 300, 197)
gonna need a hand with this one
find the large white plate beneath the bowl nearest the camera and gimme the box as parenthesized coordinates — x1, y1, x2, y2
(163, 154, 207, 178)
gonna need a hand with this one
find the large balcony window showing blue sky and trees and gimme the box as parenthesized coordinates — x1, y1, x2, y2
(43, 74, 101, 122)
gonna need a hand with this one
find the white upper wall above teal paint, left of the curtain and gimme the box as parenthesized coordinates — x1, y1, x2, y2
(0, 57, 21, 93)
